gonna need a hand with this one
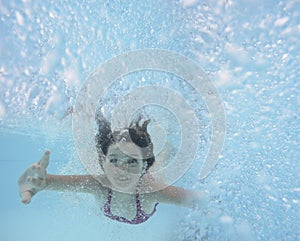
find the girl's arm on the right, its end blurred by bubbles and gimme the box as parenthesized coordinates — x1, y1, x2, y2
(155, 186, 208, 208)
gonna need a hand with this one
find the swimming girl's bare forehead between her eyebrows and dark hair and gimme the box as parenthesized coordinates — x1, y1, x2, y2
(107, 142, 142, 159)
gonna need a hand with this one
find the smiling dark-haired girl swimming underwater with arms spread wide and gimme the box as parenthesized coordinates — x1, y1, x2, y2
(18, 116, 206, 224)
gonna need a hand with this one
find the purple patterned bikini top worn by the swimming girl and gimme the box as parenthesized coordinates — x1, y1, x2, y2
(103, 189, 158, 224)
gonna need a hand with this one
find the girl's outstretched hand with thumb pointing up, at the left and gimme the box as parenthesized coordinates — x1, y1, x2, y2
(18, 150, 50, 204)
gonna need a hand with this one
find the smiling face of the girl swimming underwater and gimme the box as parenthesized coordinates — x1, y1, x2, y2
(103, 142, 144, 192)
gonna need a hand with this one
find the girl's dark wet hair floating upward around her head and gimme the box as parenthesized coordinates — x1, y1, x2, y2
(95, 113, 155, 172)
